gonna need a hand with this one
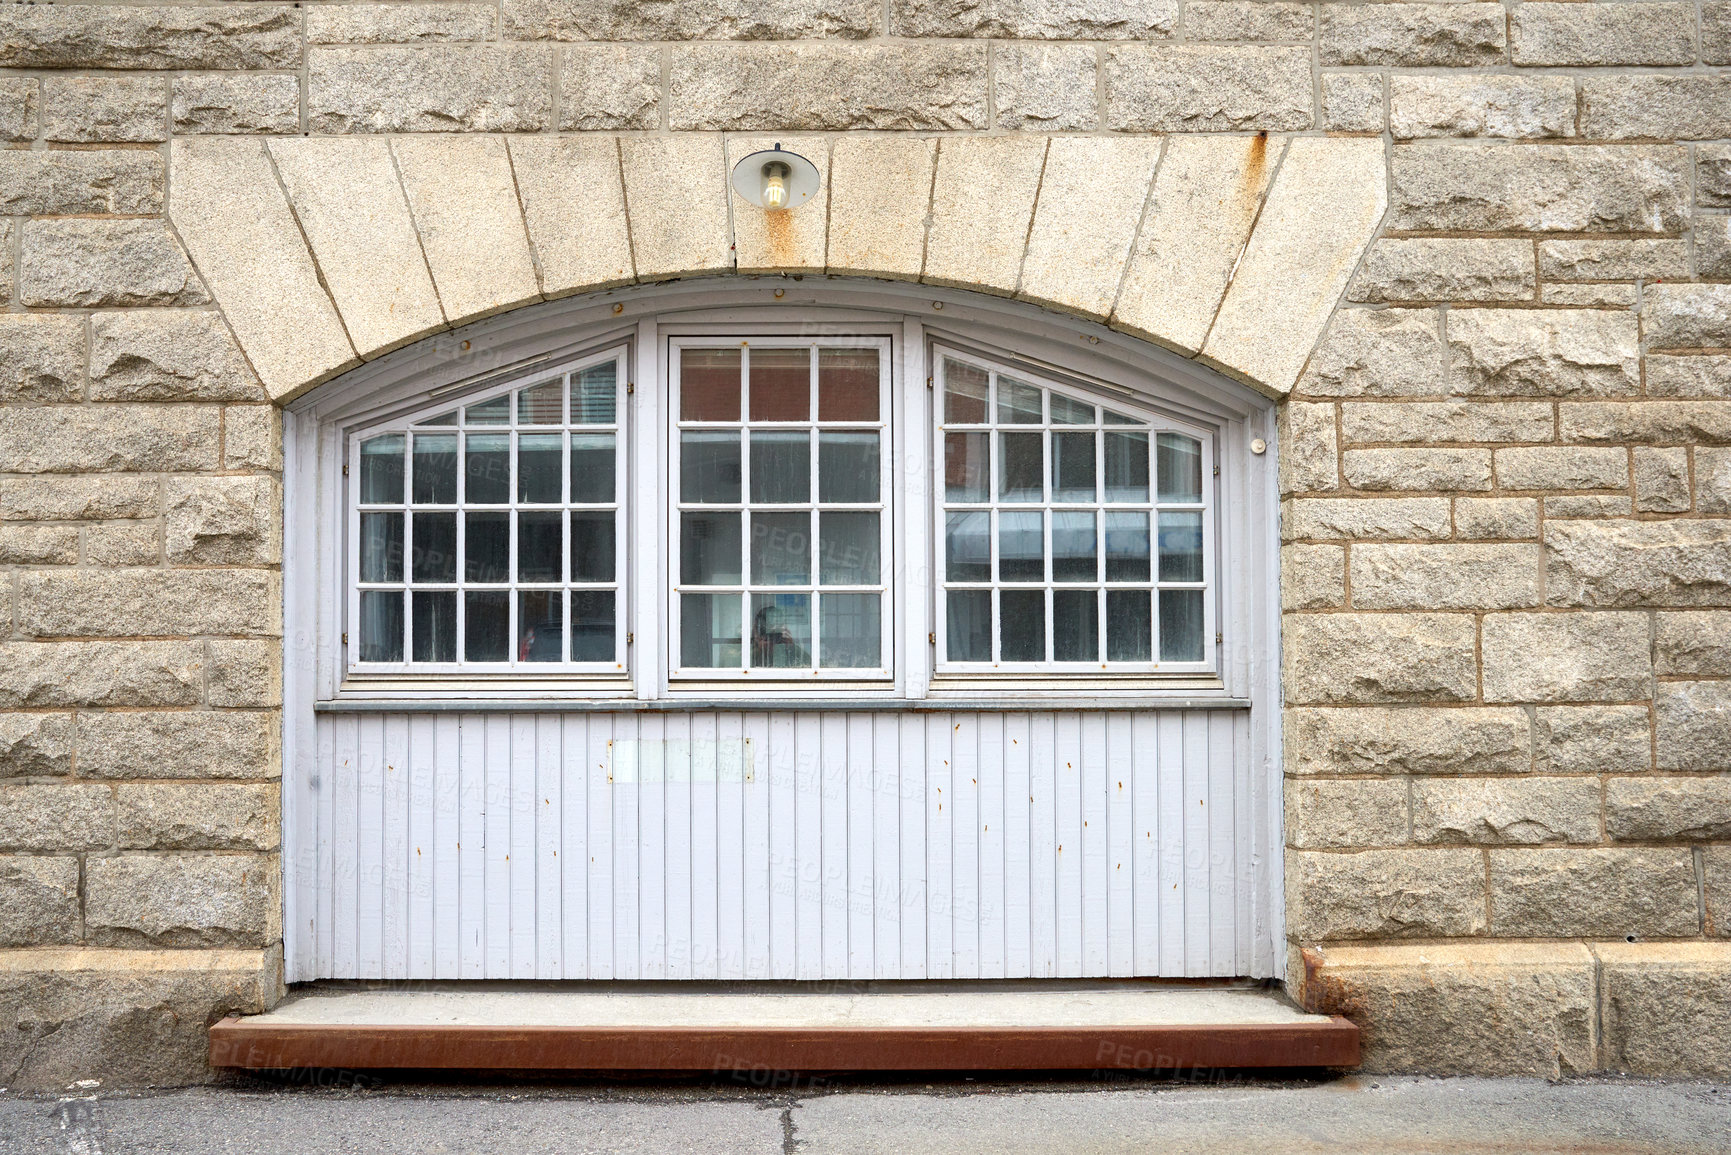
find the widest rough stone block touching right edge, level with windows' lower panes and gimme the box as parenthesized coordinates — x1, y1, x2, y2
(1544, 519, 1731, 606)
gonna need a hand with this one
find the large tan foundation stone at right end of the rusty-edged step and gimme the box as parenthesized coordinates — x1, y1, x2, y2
(1302, 942, 1598, 1079)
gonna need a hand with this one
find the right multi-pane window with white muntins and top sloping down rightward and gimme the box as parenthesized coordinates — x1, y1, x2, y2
(935, 350, 1213, 674)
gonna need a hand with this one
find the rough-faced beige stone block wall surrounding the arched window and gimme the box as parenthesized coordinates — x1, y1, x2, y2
(0, 0, 1731, 1087)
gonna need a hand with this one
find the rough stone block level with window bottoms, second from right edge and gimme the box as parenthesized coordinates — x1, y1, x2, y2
(1482, 613, 1653, 701)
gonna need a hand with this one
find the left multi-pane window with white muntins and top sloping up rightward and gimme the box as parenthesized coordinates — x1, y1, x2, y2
(350, 350, 625, 675)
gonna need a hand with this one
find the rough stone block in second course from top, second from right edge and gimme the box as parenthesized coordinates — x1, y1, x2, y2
(1388, 74, 1575, 140)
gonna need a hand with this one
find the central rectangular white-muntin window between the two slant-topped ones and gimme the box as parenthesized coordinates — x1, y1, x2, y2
(670, 338, 891, 681)
